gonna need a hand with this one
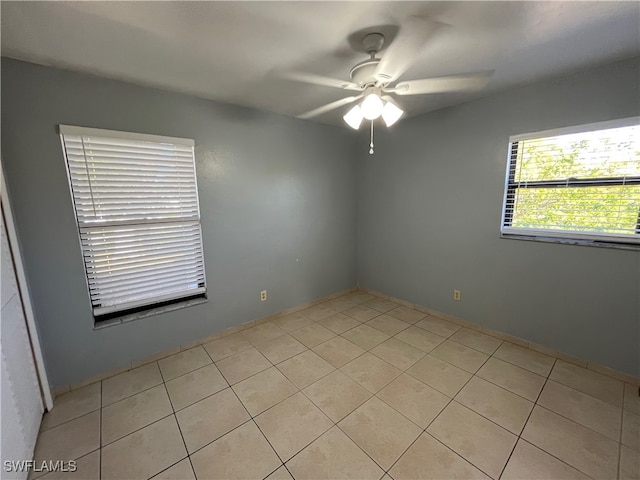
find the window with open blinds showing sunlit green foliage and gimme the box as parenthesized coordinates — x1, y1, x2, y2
(501, 118, 640, 248)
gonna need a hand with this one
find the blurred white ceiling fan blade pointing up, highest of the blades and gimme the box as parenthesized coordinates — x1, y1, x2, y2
(374, 16, 444, 83)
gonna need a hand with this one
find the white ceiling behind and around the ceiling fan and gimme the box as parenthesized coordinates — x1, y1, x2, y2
(0, 1, 640, 124)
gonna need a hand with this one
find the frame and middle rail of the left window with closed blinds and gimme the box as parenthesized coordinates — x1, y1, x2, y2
(58, 124, 208, 327)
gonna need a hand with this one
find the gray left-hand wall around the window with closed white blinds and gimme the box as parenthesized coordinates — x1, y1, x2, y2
(2, 59, 357, 386)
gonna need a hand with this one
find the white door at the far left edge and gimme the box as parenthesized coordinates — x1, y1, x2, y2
(0, 188, 44, 479)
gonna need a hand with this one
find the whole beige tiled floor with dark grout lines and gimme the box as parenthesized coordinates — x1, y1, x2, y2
(31, 293, 640, 480)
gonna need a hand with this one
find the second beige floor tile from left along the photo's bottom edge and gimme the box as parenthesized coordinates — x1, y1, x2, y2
(101, 415, 187, 480)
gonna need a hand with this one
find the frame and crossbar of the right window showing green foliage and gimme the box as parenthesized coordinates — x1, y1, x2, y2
(500, 117, 640, 250)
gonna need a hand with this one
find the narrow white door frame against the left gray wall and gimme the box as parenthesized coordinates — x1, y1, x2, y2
(0, 161, 53, 411)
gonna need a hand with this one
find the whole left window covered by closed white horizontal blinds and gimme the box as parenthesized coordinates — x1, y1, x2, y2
(60, 125, 206, 321)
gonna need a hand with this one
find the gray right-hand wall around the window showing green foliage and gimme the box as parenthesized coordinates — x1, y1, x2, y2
(358, 59, 640, 375)
